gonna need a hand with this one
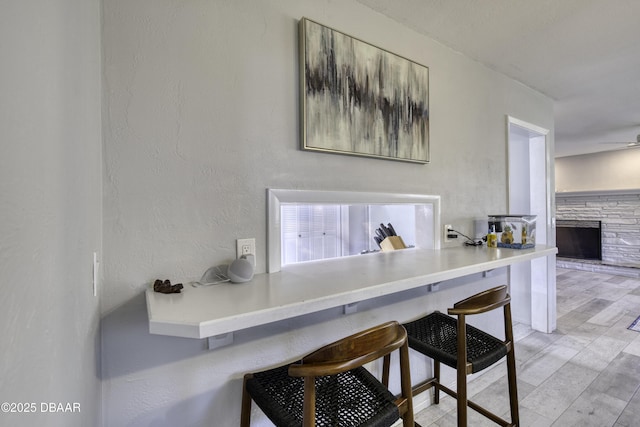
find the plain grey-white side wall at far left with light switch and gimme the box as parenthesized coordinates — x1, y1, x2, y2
(0, 0, 102, 427)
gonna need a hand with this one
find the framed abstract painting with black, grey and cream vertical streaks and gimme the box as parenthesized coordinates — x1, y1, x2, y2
(300, 18, 429, 163)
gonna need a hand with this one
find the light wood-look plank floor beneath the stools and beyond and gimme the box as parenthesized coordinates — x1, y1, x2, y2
(416, 269, 640, 427)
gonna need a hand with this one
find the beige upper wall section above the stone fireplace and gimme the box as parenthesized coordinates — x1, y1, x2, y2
(555, 149, 640, 193)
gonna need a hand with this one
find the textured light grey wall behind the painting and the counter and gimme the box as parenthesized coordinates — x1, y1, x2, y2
(102, 0, 553, 426)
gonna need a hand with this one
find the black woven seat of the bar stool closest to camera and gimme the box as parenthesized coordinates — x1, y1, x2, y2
(246, 365, 400, 427)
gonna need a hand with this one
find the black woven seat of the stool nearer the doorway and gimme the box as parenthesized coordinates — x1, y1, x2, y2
(403, 312, 507, 373)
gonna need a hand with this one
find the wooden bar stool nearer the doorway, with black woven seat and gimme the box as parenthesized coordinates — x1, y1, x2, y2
(383, 285, 520, 427)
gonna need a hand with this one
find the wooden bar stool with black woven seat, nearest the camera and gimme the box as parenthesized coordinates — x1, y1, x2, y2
(240, 322, 414, 427)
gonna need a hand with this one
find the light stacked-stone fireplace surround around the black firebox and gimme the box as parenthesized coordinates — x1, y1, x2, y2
(556, 189, 640, 277)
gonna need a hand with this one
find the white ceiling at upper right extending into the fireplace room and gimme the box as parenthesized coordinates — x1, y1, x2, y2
(358, 0, 640, 157)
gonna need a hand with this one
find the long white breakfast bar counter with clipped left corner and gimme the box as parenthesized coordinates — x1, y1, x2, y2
(146, 246, 557, 338)
